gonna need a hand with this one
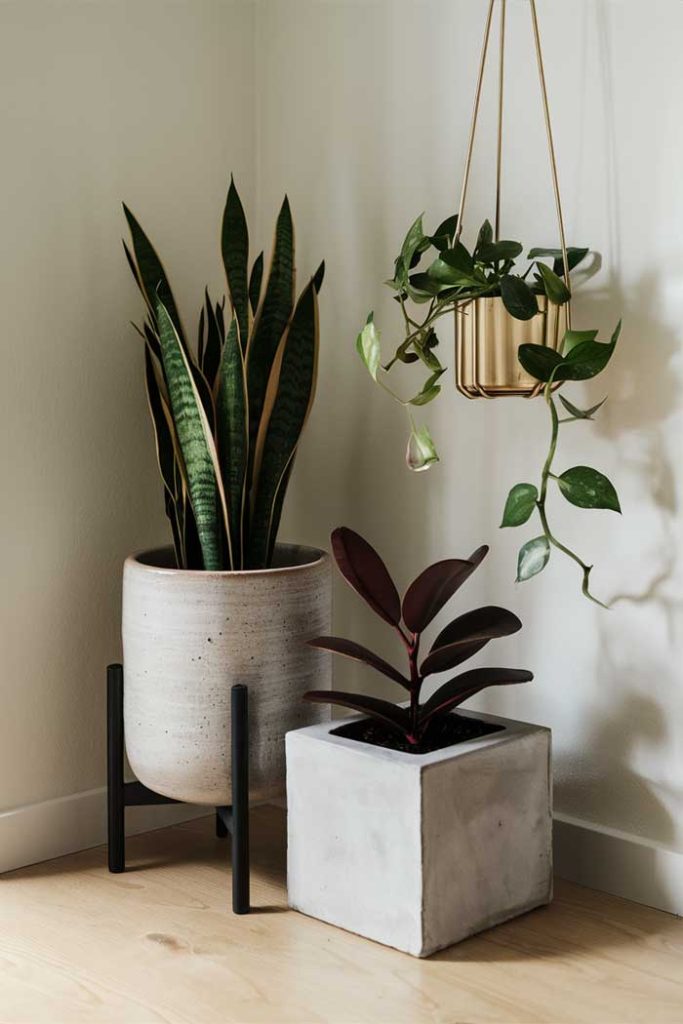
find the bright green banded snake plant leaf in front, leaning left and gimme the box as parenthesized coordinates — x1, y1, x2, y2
(156, 298, 232, 571)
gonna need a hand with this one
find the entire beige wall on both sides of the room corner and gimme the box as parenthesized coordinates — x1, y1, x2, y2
(0, 0, 683, 909)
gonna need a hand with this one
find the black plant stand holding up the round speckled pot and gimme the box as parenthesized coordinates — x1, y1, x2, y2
(106, 665, 249, 913)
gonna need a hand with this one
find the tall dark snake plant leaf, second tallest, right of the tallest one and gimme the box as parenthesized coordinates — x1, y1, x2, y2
(248, 197, 294, 466)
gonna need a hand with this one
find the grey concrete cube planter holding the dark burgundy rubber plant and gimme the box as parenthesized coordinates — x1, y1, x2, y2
(287, 711, 552, 956)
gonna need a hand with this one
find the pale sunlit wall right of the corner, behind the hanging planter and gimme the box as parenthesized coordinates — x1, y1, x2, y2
(258, 0, 683, 906)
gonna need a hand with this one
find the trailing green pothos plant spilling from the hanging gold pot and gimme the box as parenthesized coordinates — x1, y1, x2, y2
(356, 210, 621, 607)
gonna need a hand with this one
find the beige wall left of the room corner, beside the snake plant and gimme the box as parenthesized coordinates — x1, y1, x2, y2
(0, 0, 255, 811)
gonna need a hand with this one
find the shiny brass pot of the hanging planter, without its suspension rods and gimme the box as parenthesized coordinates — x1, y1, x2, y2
(456, 295, 567, 398)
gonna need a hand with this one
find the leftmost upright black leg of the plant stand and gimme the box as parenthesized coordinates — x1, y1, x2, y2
(106, 665, 126, 874)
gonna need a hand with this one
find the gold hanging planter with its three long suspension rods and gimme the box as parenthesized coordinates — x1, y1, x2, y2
(456, 0, 571, 398)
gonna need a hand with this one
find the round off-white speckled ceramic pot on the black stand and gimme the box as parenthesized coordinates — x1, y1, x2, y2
(122, 544, 332, 806)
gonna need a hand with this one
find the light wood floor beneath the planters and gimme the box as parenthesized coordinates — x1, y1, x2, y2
(0, 808, 683, 1024)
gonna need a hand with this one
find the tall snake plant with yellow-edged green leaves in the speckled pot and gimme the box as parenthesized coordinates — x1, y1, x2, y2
(124, 180, 325, 570)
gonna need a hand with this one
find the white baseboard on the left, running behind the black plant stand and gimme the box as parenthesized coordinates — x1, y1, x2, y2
(0, 787, 211, 872)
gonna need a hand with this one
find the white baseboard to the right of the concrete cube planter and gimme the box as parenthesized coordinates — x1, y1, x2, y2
(553, 814, 683, 915)
